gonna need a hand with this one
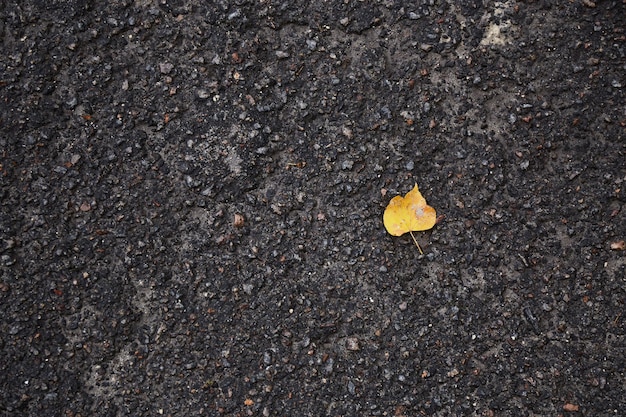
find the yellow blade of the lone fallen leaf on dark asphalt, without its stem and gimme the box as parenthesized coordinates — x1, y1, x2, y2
(383, 184, 437, 236)
